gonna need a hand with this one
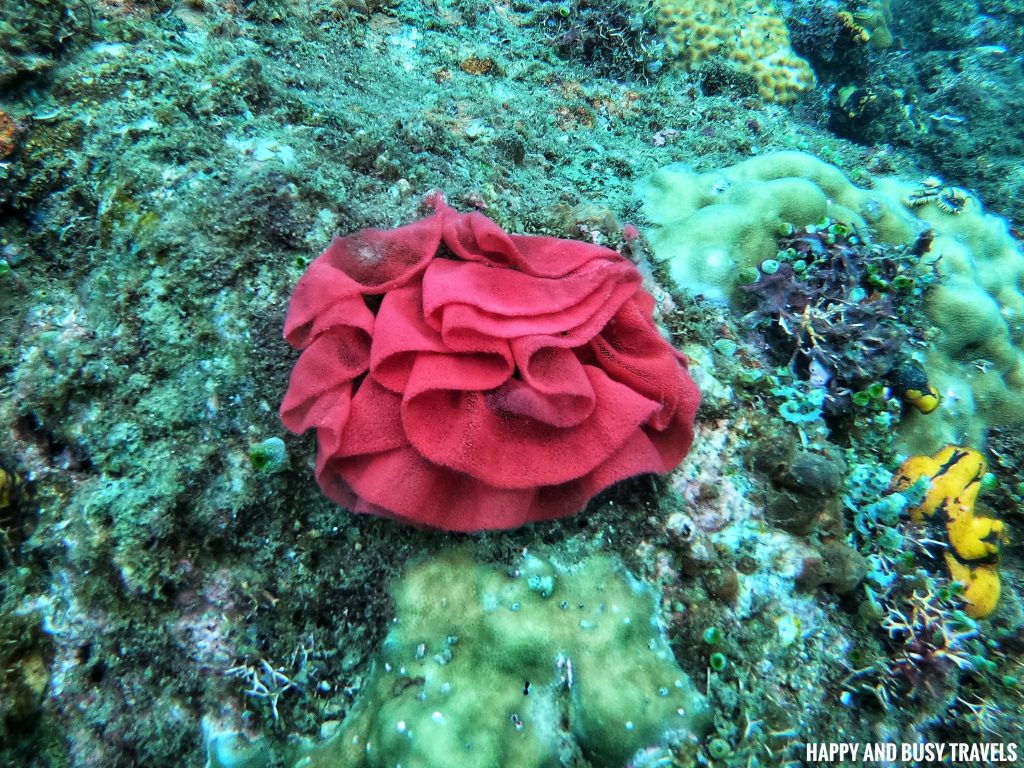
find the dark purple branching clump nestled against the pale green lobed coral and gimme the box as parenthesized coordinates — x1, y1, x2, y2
(741, 219, 937, 417)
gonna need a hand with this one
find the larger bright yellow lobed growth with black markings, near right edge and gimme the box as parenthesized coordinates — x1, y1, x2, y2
(893, 445, 1005, 618)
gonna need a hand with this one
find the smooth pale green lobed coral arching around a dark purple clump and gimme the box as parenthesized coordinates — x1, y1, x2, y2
(638, 152, 1024, 454)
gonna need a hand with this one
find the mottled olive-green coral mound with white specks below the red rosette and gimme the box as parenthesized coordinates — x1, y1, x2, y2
(295, 551, 707, 768)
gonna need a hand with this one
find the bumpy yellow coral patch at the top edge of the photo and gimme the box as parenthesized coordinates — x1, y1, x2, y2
(655, 0, 814, 103)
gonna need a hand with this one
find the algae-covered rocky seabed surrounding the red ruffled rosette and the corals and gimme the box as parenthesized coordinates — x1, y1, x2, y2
(0, 0, 1024, 768)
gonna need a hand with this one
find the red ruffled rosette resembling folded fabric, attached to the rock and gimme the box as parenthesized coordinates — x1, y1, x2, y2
(281, 196, 699, 530)
